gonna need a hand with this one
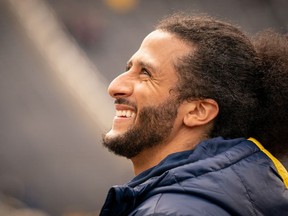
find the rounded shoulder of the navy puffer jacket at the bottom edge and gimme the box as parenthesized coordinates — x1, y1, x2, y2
(129, 193, 230, 216)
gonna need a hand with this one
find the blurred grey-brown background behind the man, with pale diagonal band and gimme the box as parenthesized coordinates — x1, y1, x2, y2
(0, 0, 288, 216)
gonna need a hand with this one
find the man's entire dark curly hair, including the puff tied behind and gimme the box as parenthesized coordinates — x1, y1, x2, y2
(156, 13, 288, 155)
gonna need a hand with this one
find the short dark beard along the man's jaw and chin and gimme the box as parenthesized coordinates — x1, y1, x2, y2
(103, 98, 179, 159)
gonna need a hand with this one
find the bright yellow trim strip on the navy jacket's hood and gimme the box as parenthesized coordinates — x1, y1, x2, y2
(248, 137, 288, 188)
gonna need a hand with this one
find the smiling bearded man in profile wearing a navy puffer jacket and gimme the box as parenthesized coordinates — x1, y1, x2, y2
(100, 14, 288, 216)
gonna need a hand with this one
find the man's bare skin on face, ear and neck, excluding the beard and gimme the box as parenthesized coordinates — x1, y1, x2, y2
(106, 30, 219, 175)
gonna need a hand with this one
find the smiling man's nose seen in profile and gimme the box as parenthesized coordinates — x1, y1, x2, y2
(108, 72, 133, 98)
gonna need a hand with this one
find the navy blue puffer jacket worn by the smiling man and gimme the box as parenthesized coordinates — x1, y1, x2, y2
(100, 138, 288, 216)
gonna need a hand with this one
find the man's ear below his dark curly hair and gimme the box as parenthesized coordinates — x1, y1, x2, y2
(183, 99, 219, 127)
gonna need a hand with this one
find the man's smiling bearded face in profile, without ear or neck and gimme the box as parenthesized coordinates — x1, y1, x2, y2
(103, 30, 190, 158)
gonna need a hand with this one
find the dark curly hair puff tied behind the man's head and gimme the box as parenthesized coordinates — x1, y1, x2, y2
(253, 30, 288, 155)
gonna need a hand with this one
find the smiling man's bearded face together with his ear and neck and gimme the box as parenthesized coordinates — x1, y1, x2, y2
(104, 30, 214, 174)
